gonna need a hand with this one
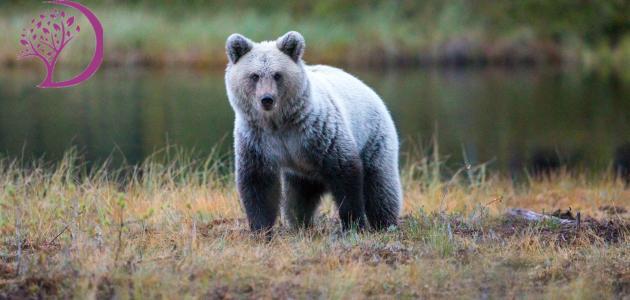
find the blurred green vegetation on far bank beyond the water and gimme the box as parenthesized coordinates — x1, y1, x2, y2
(0, 0, 630, 70)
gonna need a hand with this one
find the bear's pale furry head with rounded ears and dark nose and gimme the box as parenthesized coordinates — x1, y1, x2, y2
(225, 31, 308, 122)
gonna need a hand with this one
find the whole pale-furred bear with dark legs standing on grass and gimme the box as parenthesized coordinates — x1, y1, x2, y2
(225, 32, 402, 231)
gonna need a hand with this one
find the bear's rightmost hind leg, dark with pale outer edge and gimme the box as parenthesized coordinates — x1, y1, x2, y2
(363, 149, 402, 230)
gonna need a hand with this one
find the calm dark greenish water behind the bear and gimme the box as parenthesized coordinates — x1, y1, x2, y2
(0, 69, 630, 170)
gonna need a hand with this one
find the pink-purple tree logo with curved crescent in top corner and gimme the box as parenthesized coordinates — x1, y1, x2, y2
(18, 0, 103, 88)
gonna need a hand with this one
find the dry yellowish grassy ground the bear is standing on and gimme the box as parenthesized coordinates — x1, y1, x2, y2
(0, 149, 630, 299)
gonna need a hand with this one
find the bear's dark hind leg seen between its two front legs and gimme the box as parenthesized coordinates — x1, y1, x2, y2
(283, 173, 326, 229)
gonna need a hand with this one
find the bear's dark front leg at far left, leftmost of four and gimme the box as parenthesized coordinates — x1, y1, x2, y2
(236, 137, 281, 233)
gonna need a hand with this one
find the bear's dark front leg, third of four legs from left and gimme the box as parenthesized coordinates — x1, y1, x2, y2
(325, 155, 366, 230)
